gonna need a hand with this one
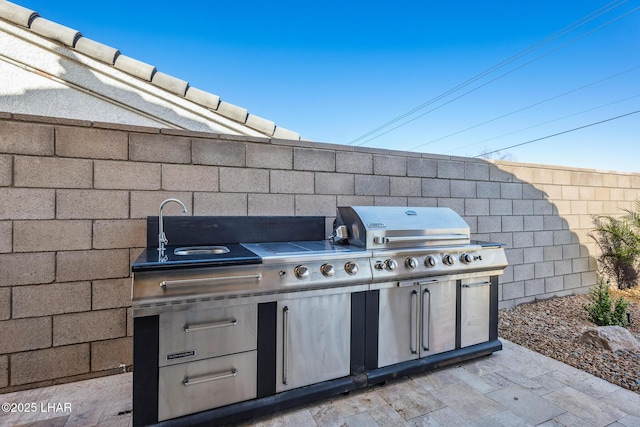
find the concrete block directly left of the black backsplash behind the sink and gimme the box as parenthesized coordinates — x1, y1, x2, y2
(93, 219, 147, 249)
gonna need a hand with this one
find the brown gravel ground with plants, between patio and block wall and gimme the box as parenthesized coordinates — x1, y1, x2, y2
(498, 287, 640, 394)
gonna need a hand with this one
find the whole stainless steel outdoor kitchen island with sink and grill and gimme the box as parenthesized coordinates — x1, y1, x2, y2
(132, 207, 507, 426)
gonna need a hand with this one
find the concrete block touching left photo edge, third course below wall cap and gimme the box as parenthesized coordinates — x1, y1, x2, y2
(0, 187, 56, 220)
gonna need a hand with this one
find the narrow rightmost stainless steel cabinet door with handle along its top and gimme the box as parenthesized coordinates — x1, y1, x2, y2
(460, 277, 491, 347)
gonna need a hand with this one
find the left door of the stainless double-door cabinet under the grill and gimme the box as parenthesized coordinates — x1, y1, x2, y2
(378, 286, 420, 367)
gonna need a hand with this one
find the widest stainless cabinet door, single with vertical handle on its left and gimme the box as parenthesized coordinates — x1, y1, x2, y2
(276, 293, 351, 392)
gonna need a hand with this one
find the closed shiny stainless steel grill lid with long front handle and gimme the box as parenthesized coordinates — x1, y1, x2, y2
(334, 206, 471, 249)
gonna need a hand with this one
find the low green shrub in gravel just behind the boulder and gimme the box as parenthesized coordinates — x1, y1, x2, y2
(584, 278, 629, 327)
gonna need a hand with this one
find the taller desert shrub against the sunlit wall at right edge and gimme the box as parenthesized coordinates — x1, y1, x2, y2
(589, 211, 640, 289)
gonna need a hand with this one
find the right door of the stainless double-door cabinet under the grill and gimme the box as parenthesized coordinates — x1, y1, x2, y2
(420, 280, 456, 357)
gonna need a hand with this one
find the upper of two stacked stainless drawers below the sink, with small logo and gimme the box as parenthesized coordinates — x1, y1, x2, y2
(158, 304, 258, 366)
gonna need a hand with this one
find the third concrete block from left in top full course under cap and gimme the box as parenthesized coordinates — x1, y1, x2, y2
(129, 133, 191, 163)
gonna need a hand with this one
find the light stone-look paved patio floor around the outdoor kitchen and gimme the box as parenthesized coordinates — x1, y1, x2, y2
(0, 340, 640, 427)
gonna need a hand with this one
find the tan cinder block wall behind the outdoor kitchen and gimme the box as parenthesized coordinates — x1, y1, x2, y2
(0, 113, 640, 392)
